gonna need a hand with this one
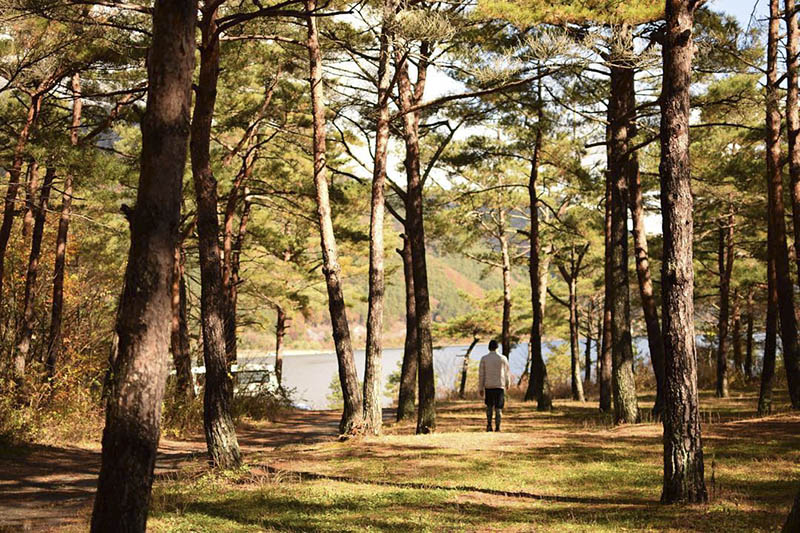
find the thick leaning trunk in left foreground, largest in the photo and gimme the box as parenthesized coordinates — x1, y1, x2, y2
(91, 0, 197, 533)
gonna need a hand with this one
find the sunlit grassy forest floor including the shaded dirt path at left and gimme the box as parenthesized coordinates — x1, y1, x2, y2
(0, 392, 800, 532)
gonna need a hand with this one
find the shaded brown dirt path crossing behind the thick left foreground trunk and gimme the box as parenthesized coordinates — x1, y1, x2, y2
(0, 411, 339, 532)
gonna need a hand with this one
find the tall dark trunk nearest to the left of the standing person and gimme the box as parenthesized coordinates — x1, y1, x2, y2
(397, 47, 436, 433)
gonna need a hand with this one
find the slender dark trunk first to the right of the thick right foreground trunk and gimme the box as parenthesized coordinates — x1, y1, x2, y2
(716, 206, 734, 398)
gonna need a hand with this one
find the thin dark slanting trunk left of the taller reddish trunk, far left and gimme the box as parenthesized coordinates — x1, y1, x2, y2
(14, 167, 56, 379)
